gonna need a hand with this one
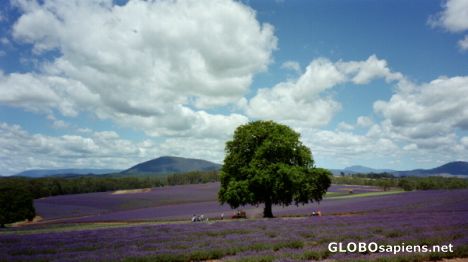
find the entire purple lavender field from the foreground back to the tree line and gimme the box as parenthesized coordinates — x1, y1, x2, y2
(0, 184, 468, 261)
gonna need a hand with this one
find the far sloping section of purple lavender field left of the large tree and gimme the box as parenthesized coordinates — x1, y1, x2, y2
(34, 183, 219, 221)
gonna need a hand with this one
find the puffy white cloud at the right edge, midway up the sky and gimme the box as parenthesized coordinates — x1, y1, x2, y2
(374, 76, 468, 137)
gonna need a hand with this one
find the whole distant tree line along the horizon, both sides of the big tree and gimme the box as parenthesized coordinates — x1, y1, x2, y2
(0, 171, 468, 199)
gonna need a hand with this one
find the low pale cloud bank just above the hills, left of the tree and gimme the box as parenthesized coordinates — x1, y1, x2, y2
(0, 122, 230, 175)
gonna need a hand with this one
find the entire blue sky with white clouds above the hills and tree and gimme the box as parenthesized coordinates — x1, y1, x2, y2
(0, 0, 468, 175)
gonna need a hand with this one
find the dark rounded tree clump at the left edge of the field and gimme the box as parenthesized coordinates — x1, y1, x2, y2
(0, 180, 36, 227)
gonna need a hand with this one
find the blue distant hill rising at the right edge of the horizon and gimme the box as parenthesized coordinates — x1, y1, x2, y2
(395, 161, 468, 176)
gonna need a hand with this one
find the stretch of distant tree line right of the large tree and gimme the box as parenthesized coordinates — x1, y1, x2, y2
(332, 173, 468, 191)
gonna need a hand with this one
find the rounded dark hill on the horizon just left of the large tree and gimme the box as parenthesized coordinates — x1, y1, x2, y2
(121, 156, 221, 174)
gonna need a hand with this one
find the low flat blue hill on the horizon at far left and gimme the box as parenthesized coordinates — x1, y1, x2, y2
(15, 168, 120, 177)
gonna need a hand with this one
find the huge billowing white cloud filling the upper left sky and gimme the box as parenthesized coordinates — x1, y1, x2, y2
(0, 0, 277, 138)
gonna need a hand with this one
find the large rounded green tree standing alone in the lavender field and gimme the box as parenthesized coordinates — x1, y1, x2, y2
(218, 121, 331, 217)
